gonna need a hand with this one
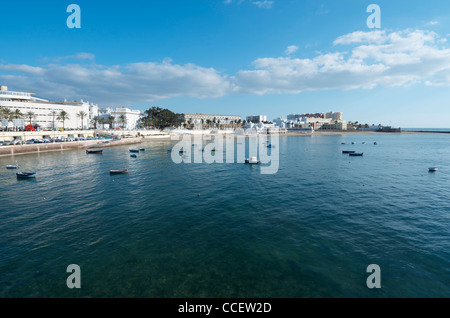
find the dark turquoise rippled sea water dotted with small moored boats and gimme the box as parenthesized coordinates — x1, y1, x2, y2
(0, 134, 450, 298)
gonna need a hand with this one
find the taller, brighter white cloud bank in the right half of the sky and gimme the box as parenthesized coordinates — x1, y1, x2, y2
(232, 30, 450, 94)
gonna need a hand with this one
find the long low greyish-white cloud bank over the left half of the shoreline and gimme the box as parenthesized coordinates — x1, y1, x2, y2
(0, 59, 232, 104)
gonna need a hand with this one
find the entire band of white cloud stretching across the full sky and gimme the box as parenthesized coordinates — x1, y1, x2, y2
(0, 30, 450, 105)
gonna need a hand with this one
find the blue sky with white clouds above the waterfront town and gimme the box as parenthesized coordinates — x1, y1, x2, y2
(0, 0, 450, 127)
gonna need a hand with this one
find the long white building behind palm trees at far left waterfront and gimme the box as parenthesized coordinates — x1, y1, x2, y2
(0, 86, 98, 130)
